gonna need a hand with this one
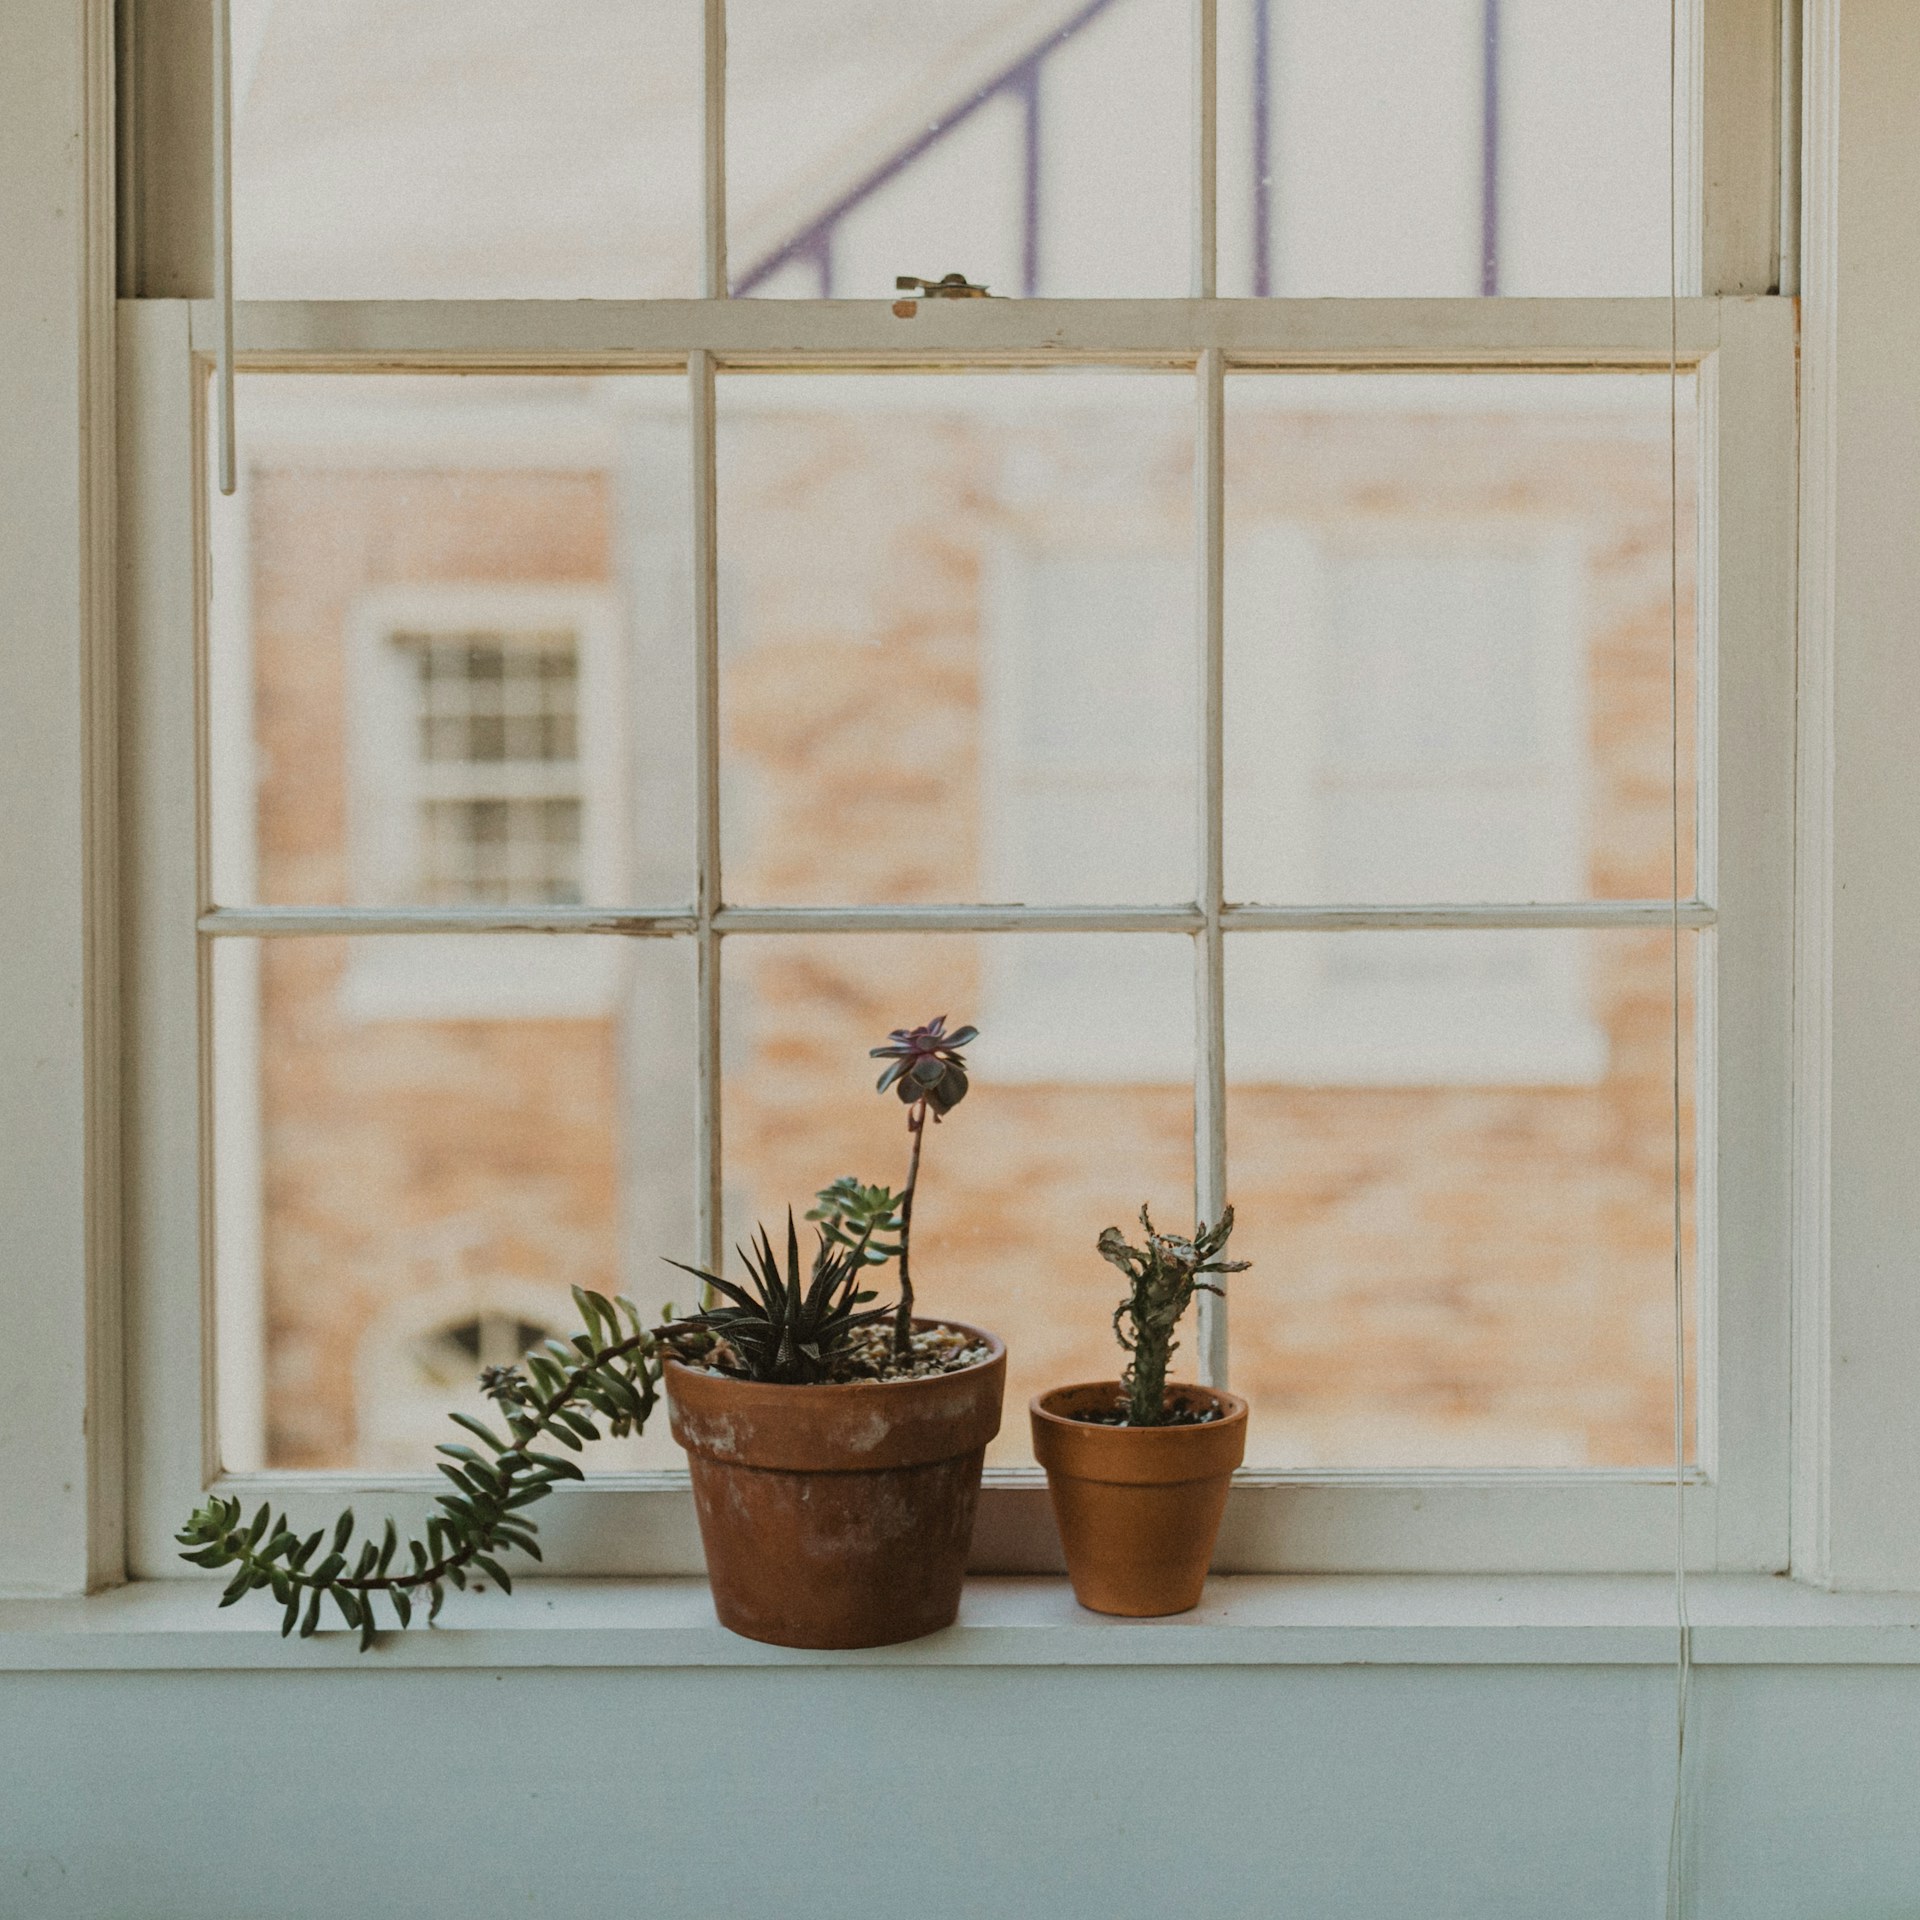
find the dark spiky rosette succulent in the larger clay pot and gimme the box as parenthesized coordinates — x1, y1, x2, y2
(660, 1208, 889, 1386)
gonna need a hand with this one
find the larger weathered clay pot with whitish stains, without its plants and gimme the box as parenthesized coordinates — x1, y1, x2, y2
(666, 1321, 1006, 1647)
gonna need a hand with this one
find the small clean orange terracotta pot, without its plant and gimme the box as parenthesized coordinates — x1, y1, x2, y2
(1027, 1380, 1246, 1615)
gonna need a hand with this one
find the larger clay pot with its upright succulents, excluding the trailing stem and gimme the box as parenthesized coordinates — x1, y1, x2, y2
(662, 1016, 1006, 1647)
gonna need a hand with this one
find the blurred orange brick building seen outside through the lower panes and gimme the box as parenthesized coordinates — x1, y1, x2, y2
(228, 376, 1690, 1465)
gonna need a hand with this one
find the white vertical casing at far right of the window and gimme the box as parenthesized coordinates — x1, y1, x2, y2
(1805, 0, 1920, 1588)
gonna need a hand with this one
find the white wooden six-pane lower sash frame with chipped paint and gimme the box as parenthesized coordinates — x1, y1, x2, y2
(97, 0, 1797, 1576)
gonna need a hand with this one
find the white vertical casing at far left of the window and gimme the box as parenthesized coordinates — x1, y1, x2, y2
(0, 0, 125, 1592)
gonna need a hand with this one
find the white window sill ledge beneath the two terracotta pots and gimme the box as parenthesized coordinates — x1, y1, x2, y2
(0, 1574, 1920, 1672)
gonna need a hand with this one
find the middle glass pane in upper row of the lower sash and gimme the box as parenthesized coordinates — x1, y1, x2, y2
(718, 371, 1198, 904)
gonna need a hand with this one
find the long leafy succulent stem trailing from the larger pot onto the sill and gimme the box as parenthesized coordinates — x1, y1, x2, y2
(175, 1286, 660, 1649)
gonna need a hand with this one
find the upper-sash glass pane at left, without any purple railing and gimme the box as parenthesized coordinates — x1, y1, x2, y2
(232, 0, 703, 300)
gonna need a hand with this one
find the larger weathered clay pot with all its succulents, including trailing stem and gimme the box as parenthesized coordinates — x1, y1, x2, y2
(177, 1018, 1006, 1647)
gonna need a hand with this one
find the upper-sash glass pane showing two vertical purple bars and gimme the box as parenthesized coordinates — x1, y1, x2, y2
(1219, 0, 1690, 298)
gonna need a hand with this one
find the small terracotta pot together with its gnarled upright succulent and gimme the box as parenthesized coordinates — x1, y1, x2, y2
(1029, 1206, 1248, 1615)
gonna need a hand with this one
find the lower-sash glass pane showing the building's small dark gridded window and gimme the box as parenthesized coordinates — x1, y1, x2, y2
(207, 374, 693, 906)
